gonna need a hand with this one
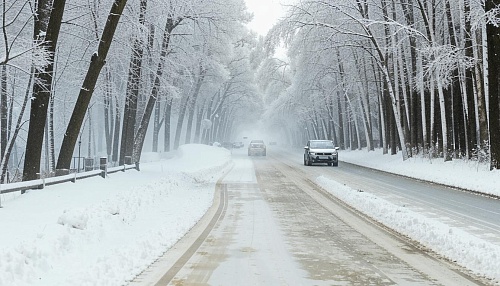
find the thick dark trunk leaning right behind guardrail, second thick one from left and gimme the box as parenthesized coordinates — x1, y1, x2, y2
(56, 0, 127, 169)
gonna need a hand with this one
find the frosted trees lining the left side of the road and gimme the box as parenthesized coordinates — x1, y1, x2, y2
(0, 0, 263, 183)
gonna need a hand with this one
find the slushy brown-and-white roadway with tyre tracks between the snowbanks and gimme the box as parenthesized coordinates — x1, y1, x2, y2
(131, 150, 492, 285)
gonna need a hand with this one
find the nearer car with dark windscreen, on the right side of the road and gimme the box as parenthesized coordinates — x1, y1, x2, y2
(304, 140, 339, 167)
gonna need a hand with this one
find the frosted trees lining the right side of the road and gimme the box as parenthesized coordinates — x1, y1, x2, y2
(260, 0, 500, 169)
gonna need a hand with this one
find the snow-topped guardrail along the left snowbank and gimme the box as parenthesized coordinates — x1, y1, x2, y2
(0, 163, 140, 198)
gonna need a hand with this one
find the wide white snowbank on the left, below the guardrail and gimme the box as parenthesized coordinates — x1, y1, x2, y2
(0, 145, 231, 286)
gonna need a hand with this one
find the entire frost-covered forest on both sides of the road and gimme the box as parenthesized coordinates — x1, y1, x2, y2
(0, 0, 500, 183)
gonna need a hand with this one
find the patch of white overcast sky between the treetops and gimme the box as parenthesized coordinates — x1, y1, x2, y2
(245, 0, 284, 36)
